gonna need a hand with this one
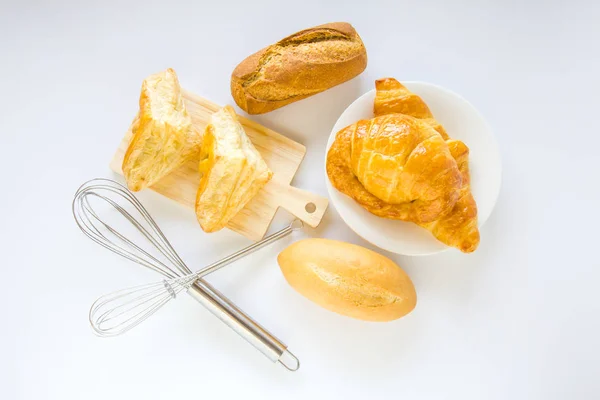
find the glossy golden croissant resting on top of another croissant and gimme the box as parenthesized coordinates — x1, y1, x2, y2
(326, 114, 462, 223)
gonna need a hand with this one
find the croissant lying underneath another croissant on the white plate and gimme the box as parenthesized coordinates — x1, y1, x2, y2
(374, 78, 479, 253)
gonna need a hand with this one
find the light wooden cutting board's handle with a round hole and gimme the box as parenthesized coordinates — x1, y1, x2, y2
(273, 182, 329, 228)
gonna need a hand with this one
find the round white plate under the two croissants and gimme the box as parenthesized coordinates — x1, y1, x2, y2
(325, 82, 502, 256)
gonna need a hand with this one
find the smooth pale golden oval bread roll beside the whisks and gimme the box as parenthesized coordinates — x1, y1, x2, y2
(277, 239, 417, 321)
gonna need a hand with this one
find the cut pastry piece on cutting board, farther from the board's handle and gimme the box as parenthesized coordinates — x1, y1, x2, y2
(122, 68, 202, 191)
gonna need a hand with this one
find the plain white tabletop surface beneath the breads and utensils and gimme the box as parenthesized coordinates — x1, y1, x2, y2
(0, 0, 600, 400)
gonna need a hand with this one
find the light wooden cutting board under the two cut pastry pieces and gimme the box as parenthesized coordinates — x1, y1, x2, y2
(110, 90, 328, 240)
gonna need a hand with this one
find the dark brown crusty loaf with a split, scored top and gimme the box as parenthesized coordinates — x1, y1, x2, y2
(231, 22, 367, 114)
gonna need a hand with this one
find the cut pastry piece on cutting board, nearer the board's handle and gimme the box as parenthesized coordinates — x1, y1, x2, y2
(196, 106, 273, 232)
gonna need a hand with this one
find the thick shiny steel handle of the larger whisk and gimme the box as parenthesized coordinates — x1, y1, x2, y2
(188, 279, 300, 371)
